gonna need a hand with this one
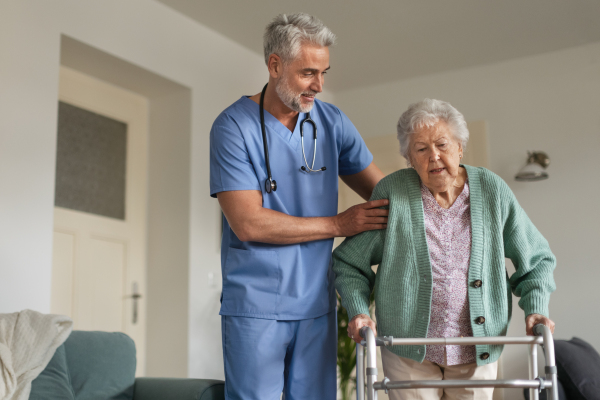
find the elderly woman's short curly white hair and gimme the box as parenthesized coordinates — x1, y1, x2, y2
(398, 99, 469, 162)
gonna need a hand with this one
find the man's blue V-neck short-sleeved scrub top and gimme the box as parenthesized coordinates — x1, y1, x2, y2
(210, 96, 373, 320)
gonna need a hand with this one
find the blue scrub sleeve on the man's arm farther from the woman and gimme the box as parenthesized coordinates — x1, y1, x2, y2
(210, 116, 260, 197)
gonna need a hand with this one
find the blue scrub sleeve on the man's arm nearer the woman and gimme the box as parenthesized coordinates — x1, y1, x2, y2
(338, 109, 373, 175)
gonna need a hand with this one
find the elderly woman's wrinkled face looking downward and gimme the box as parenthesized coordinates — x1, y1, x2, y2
(408, 121, 463, 192)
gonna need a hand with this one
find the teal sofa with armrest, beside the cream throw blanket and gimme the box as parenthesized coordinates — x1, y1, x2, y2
(29, 331, 225, 400)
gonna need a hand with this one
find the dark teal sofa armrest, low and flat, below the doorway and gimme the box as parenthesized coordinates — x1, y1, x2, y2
(133, 378, 225, 400)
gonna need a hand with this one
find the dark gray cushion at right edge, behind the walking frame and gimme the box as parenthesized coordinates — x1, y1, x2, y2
(554, 337, 600, 400)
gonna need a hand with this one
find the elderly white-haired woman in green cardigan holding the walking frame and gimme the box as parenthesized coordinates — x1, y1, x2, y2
(333, 99, 556, 399)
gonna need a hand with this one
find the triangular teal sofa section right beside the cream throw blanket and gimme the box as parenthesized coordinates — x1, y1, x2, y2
(29, 344, 75, 400)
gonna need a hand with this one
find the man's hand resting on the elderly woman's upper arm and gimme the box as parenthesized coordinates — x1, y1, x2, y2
(335, 199, 389, 237)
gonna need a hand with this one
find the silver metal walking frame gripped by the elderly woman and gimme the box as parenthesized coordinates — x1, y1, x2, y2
(356, 324, 558, 400)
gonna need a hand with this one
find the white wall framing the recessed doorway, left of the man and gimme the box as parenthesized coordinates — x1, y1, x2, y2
(0, 0, 267, 378)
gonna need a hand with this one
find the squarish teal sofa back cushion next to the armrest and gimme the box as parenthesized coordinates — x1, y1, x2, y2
(64, 331, 136, 400)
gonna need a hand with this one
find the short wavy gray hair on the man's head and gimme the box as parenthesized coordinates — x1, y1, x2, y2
(263, 13, 335, 64)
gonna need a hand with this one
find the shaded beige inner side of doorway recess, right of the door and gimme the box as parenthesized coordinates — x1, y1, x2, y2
(146, 89, 191, 377)
